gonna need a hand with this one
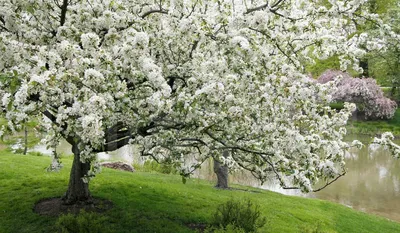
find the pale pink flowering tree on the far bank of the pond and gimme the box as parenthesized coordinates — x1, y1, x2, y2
(318, 70, 397, 119)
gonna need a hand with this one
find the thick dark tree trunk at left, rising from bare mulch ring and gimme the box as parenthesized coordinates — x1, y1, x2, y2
(63, 144, 93, 205)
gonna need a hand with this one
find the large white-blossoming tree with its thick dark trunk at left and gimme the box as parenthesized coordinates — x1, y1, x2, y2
(0, 0, 398, 204)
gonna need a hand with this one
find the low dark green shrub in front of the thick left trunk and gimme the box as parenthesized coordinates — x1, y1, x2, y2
(56, 210, 110, 233)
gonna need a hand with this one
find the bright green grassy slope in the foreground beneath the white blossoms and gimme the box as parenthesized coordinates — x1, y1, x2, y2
(0, 151, 400, 233)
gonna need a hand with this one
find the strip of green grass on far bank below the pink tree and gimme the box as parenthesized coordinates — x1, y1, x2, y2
(347, 108, 400, 137)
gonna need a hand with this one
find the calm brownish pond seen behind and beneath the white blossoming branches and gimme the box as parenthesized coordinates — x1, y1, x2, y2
(27, 135, 400, 222)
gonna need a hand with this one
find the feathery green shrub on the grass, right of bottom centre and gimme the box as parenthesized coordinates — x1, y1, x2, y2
(212, 199, 267, 232)
